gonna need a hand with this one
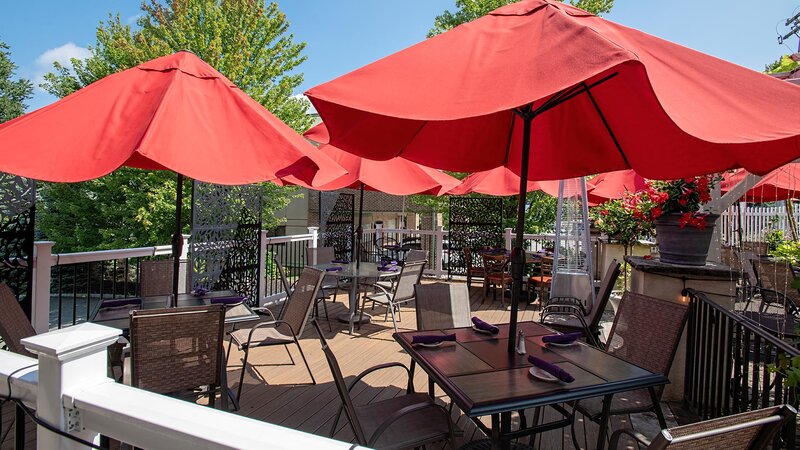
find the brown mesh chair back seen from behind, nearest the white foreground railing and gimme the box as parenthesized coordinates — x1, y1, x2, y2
(130, 305, 225, 394)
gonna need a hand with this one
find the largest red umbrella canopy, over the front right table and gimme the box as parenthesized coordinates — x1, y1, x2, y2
(307, 0, 800, 180)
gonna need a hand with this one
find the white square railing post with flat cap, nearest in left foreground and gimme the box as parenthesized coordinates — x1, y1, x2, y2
(22, 323, 119, 449)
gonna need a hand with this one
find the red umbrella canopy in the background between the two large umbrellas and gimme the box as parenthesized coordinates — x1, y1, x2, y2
(290, 123, 460, 195)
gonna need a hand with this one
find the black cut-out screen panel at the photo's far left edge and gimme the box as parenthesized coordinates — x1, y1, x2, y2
(0, 173, 36, 317)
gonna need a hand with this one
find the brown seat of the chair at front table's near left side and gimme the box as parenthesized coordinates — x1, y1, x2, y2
(356, 394, 449, 449)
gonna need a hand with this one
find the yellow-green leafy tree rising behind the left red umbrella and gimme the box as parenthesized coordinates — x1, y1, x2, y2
(38, 0, 313, 251)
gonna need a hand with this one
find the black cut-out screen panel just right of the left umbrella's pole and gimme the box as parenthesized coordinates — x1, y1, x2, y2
(190, 181, 262, 304)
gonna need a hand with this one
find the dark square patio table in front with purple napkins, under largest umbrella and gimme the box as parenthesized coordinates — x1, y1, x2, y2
(394, 322, 669, 449)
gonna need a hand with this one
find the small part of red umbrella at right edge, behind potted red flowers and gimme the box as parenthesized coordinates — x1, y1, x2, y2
(720, 163, 800, 203)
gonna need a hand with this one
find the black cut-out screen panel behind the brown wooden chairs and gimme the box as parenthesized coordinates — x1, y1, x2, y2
(447, 196, 503, 276)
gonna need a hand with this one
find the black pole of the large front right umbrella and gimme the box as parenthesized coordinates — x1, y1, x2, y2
(508, 105, 535, 353)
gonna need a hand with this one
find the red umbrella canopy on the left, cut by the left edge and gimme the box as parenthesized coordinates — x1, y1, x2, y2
(0, 52, 344, 185)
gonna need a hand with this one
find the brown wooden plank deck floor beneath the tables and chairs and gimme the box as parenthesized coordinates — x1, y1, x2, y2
(228, 287, 672, 449)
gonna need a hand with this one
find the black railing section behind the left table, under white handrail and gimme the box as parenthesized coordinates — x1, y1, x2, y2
(50, 256, 169, 329)
